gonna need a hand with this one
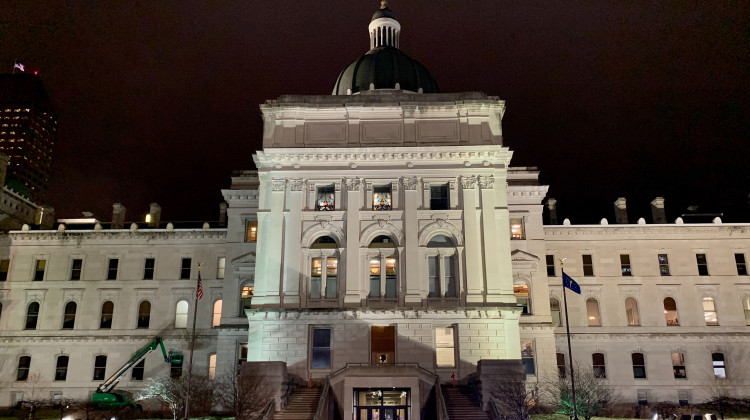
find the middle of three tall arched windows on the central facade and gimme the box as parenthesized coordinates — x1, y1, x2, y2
(368, 235, 398, 299)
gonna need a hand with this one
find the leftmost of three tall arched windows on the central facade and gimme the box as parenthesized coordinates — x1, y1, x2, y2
(309, 236, 339, 299)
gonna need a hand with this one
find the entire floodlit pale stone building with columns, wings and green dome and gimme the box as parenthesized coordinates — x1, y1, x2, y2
(0, 5, 750, 419)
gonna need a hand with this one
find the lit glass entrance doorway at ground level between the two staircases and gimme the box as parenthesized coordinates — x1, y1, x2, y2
(354, 388, 411, 420)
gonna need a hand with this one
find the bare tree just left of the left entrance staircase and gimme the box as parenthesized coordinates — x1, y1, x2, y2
(216, 370, 274, 420)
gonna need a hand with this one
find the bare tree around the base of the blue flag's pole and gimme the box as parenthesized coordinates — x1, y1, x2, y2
(544, 366, 617, 420)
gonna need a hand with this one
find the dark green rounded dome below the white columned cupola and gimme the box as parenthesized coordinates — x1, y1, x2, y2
(333, 47, 440, 95)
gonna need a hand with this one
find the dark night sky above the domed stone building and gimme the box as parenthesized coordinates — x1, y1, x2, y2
(0, 0, 750, 223)
